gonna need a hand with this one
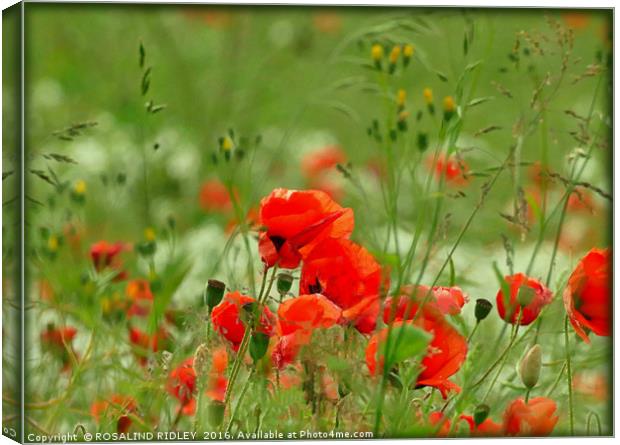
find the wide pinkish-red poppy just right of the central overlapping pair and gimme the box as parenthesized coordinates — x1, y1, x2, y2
(383, 285, 469, 323)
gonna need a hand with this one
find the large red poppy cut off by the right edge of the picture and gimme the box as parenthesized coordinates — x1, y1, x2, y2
(563, 248, 611, 343)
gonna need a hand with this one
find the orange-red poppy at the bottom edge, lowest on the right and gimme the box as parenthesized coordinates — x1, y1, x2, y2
(504, 397, 558, 437)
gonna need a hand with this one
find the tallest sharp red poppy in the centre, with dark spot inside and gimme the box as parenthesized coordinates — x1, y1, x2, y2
(258, 189, 353, 268)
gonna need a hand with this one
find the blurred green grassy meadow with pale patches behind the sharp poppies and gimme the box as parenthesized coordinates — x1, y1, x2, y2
(3, 4, 612, 437)
